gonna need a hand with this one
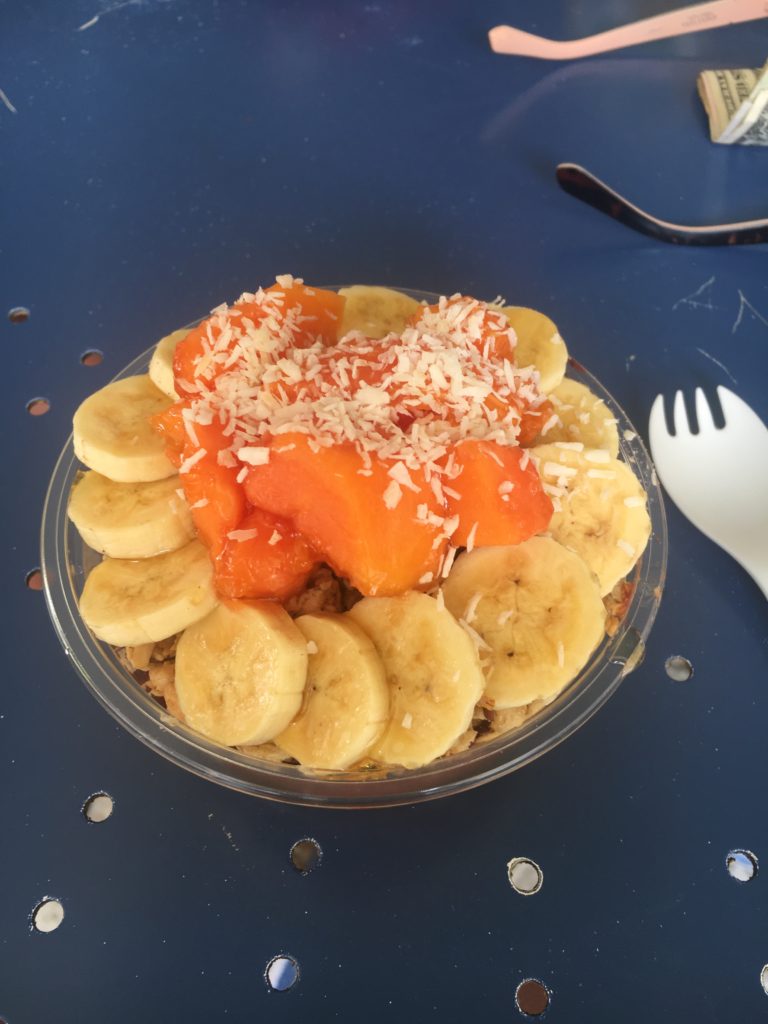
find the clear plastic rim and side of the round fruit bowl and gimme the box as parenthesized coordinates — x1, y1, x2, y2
(41, 289, 667, 808)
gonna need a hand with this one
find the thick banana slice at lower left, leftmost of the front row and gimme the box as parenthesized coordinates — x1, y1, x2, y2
(176, 601, 307, 746)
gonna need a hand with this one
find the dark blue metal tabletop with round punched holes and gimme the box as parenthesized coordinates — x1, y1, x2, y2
(0, 0, 768, 1024)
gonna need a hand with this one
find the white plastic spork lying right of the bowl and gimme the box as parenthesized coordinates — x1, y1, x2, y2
(648, 387, 768, 597)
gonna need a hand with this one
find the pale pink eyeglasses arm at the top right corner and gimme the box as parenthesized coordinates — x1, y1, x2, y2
(488, 0, 768, 60)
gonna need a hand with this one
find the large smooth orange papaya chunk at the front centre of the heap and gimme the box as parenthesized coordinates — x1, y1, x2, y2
(246, 434, 446, 596)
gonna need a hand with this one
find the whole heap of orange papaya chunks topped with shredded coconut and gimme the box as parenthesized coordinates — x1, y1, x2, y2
(153, 276, 553, 599)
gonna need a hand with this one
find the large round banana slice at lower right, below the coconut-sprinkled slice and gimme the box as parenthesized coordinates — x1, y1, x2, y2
(442, 537, 605, 709)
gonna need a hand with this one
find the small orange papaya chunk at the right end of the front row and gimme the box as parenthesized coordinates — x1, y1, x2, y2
(449, 440, 552, 547)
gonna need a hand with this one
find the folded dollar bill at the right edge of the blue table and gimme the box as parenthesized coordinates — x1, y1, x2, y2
(696, 63, 768, 145)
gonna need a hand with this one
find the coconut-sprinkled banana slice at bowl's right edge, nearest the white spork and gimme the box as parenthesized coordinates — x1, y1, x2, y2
(529, 444, 650, 596)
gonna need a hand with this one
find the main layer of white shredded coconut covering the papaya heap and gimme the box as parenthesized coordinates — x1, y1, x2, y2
(177, 274, 557, 512)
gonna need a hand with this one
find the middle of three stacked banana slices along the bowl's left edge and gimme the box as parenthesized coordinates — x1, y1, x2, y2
(68, 469, 195, 558)
